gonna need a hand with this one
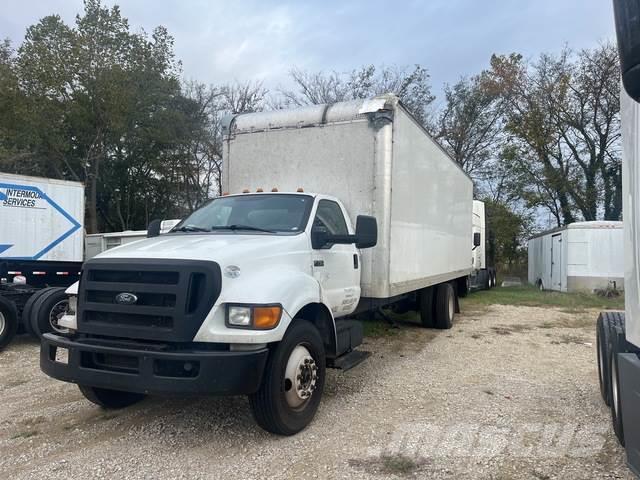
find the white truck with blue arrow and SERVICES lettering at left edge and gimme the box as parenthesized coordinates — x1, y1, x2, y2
(0, 173, 84, 349)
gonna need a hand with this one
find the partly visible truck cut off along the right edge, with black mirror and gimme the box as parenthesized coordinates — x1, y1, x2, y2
(597, 0, 640, 477)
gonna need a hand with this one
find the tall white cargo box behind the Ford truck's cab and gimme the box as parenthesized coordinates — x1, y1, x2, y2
(223, 96, 473, 298)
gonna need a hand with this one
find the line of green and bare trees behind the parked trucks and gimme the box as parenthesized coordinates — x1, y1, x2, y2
(0, 0, 622, 263)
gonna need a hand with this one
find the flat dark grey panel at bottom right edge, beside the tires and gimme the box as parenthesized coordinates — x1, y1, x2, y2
(619, 353, 640, 478)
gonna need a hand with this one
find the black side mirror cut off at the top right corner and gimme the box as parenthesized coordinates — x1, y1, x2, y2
(613, 0, 640, 102)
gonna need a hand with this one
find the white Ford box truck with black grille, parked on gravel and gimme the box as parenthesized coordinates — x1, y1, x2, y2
(41, 95, 473, 435)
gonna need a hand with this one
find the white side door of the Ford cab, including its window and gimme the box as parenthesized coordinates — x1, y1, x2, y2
(311, 199, 360, 317)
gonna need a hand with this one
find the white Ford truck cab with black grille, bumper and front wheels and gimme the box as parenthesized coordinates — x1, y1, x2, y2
(41, 192, 377, 434)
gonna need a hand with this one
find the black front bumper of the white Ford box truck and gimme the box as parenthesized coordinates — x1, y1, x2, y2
(40, 333, 268, 395)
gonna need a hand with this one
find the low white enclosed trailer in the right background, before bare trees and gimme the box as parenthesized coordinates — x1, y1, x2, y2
(528, 221, 624, 292)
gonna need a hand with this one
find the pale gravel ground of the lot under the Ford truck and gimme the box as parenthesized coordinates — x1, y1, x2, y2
(0, 306, 632, 480)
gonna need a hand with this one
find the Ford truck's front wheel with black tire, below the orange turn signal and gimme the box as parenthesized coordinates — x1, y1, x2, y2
(249, 319, 326, 435)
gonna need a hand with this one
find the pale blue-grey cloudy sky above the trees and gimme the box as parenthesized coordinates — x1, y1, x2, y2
(0, 0, 614, 100)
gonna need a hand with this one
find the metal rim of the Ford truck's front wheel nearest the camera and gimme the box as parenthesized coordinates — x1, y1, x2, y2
(284, 345, 318, 410)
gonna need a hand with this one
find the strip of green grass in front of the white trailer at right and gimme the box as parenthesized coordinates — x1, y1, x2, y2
(461, 285, 624, 313)
